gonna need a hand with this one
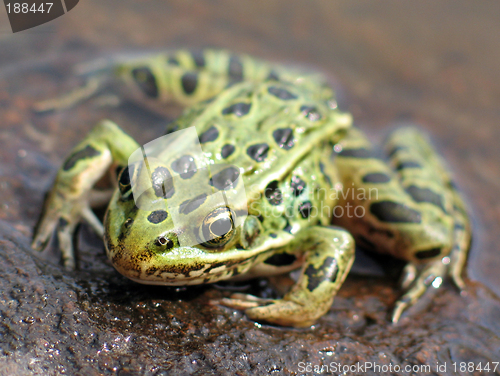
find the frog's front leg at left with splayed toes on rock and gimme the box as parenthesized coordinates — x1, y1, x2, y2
(32, 120, 139, 269)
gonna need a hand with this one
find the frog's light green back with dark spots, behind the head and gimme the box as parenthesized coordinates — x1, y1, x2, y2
(167, 80, 351, 191)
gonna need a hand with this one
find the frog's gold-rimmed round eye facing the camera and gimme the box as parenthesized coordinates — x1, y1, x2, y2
(201, 206, 234, 248)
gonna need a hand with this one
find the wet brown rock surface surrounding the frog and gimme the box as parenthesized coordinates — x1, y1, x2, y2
(0, 0, 500, 375)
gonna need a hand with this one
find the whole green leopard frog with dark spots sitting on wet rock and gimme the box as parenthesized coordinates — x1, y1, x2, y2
(32, 49, 471, 328)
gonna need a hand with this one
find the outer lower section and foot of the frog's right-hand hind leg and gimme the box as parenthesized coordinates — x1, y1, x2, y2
(386, 127, 471, 322)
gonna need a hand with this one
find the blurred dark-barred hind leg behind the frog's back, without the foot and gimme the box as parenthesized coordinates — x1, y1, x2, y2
(116, 49, 333, 106)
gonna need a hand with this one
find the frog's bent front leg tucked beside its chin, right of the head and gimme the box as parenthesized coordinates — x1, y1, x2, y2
(221, 226, 354, 327)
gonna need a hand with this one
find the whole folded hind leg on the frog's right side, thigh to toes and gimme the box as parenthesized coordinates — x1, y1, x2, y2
(334, 128, 470, 321)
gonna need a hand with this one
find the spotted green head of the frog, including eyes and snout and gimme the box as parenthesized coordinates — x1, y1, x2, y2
(105, 162, 262, 285)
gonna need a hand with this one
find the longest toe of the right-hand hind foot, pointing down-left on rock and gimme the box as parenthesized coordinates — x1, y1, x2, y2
(392, 260, 447, 323)
